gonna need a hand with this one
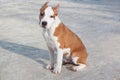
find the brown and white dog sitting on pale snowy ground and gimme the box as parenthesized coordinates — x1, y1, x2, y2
(39, 2, 87, 74)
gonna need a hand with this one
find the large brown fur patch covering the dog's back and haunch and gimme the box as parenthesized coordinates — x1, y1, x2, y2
(54, 23, 87, 64)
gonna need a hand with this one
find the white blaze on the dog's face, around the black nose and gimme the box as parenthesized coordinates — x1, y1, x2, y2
(40, 7, 55, 29)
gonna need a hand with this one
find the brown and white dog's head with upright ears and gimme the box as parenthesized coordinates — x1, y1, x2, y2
(39, 2, 59, 29)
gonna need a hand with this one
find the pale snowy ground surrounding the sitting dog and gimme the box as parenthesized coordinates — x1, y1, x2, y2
(0, 0, 120, 80)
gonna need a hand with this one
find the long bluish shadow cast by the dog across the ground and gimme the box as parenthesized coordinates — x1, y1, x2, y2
(0, 40, 49, 67)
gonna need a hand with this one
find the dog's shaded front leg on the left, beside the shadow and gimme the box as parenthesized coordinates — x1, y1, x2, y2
(46, 46, 54, 70)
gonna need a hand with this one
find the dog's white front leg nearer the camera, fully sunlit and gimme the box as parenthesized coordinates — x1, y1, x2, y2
(53, 49, 63, 74)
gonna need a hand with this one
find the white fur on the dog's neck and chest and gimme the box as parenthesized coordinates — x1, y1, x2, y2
(43, 17, 61, 49)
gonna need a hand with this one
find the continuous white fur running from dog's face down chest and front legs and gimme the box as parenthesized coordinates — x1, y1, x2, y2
(41, 7, 63, 74)
